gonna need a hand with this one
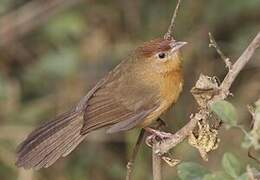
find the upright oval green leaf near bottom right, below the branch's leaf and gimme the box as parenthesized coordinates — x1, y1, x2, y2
(222, 153, 242, 178)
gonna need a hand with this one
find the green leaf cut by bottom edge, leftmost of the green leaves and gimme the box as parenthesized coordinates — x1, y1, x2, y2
(177, 162, 209, 180)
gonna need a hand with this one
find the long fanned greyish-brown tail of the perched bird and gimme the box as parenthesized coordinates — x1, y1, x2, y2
(16, 110, 86, 169)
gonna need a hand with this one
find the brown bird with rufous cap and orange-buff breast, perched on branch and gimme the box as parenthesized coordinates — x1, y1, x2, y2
(16, 38, 186, 169)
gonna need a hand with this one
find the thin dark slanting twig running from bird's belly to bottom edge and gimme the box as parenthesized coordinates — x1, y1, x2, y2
(126, 129, 145, 180)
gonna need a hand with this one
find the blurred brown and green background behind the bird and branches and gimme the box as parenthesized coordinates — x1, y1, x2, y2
(0, 0, 260, 180)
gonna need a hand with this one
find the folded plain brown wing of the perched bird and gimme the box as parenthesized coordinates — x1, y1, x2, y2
(81, 62, 159, 134)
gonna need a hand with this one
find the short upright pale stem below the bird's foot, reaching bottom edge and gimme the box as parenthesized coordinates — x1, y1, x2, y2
(152, 141, 162, 180)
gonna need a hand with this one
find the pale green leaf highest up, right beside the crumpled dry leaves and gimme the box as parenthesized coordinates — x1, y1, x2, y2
(211, 100, 237, 127)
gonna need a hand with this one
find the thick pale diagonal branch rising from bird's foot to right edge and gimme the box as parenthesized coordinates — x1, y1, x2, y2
(155, 32, 260, 155)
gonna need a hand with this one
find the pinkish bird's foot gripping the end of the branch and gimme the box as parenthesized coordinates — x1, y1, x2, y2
(144, 127, 172, 147)
